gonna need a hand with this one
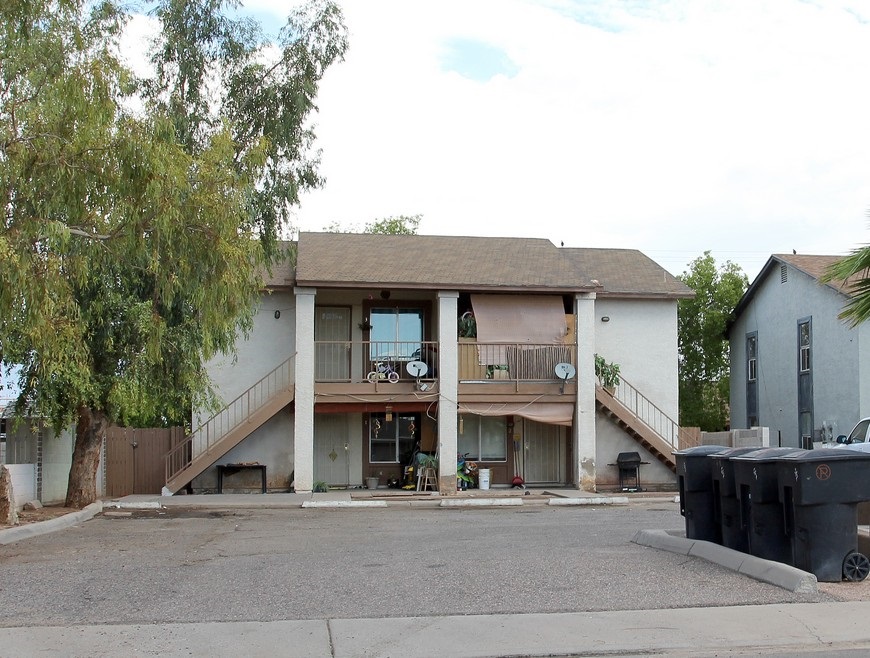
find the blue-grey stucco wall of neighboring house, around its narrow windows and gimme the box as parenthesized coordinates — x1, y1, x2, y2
(729, 267, 870, 446)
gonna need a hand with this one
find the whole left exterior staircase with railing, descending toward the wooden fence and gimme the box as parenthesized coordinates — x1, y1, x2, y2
(163, 357, 295, 495)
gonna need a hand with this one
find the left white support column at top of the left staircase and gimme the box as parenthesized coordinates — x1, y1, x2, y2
(293, 288, 317, 493)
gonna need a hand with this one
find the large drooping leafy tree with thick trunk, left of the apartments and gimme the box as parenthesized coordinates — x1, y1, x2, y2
(0, 0, 346, 507)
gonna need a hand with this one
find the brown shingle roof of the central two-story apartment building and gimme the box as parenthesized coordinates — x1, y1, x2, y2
(278, 233, 694, 298)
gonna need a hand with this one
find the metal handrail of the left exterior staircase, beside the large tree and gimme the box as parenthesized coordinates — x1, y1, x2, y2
(165, 354, 296, 482)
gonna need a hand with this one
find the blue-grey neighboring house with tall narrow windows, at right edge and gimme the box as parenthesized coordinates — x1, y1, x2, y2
(728, 254, 870, 447)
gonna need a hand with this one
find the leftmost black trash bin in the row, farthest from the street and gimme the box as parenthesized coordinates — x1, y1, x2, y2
(674, 446, 727, 544)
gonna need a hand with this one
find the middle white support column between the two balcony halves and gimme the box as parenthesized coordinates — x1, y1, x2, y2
(438, 290, 459, 494)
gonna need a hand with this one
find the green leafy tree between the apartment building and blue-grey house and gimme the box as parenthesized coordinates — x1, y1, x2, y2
(677, 251, 749, 431)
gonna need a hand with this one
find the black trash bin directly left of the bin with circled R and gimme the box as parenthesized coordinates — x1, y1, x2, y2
(730, 448, 806, 564)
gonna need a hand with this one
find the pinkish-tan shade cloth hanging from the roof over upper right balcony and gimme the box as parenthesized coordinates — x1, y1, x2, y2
(471, 295, 568, 365)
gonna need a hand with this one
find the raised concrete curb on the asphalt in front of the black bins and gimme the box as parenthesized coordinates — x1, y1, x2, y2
(632, 530, 819, 594)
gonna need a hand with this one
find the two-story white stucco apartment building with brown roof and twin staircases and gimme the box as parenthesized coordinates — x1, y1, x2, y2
(167, 233, 692, 494)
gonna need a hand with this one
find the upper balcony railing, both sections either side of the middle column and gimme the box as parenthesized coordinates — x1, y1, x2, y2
(314, 341, 576, 382)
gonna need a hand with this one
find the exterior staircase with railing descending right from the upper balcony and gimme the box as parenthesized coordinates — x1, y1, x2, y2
(595, 379, 681, 473)
